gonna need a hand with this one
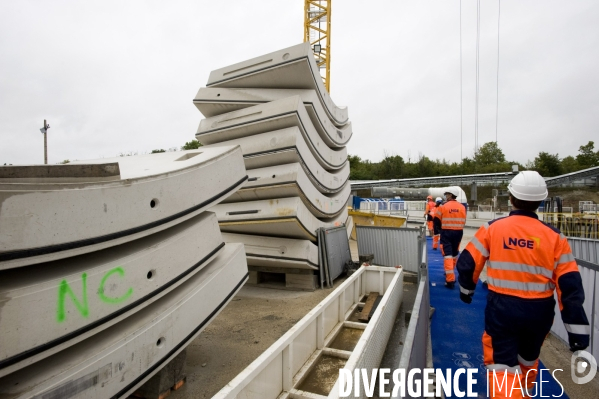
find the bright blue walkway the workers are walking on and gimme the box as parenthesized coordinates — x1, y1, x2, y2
(427, 237, 569, 399)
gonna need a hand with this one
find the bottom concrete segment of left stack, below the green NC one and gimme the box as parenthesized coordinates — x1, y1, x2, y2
(0, 244, 248, 398)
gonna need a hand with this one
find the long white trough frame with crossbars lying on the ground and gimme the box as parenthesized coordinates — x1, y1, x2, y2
(214, 266, 405, 399)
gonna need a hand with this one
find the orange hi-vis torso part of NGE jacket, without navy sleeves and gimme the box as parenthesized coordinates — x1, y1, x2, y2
(466, 211, 578, 300)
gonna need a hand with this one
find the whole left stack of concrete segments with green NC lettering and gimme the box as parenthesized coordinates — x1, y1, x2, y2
(0, 146, 248, 398)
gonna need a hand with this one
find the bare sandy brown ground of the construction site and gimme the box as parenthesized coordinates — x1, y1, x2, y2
(170, 225, 599, 399)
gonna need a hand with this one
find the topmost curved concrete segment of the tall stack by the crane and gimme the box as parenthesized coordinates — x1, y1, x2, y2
(206, 43, 348, 126)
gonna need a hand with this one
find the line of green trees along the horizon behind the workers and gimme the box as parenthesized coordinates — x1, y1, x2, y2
(348, 141, 599, 180)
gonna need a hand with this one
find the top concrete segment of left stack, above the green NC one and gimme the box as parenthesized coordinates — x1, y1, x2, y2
(0, 147, 247, 270)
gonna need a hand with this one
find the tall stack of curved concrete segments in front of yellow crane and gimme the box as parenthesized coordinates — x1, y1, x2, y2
(194, 43, 353, 289)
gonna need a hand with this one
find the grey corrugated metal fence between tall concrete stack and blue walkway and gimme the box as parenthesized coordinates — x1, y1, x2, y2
(356, 225, 426, 273)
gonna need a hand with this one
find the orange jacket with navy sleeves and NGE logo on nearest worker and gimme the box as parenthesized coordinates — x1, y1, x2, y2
(457, 210, 590, 334)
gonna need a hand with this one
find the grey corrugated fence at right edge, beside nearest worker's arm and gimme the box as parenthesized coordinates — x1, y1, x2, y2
(551, 237, 599, 366)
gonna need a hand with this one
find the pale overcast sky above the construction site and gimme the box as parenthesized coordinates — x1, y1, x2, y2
(0, 0, 599, 164)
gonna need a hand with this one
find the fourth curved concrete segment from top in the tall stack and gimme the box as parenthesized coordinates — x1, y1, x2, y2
(202, 126, 350, 194)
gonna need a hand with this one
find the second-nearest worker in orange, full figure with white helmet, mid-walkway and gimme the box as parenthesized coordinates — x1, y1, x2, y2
(435, 187, 466, 289)
